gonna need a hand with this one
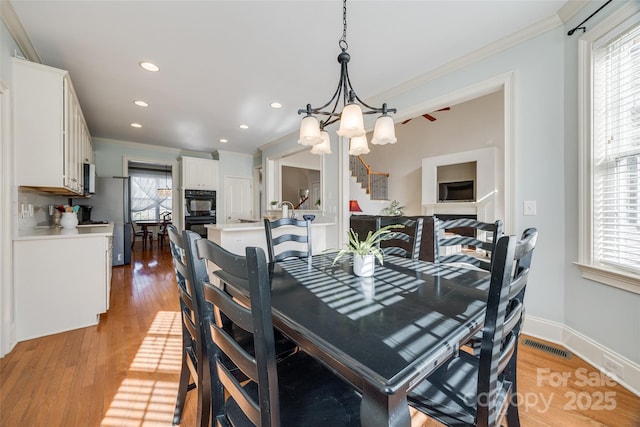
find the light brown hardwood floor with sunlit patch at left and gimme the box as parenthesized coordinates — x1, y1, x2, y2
(0, 245, 640, 427)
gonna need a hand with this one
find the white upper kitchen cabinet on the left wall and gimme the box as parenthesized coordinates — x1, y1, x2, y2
(13, 58, 93, 195)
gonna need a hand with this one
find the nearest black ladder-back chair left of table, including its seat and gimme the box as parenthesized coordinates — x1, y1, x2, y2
(197, 239, 361, 427)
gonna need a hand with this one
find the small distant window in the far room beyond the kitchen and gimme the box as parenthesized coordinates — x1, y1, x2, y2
(129, 167, 172, 221)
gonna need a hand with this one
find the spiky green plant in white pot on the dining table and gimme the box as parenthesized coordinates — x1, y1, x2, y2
(333, 224, 404, 277)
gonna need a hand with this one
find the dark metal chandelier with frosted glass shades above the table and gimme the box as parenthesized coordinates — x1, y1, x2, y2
(298, 0, 396, 156)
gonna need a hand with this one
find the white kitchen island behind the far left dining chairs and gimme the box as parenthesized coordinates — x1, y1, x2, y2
(205, 217, 336, 256)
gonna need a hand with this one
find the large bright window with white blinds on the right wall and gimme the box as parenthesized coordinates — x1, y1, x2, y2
(579, 9, 640, 293)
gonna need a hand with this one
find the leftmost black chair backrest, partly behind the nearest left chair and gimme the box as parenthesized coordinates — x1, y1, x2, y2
(167, 224, 212, 425)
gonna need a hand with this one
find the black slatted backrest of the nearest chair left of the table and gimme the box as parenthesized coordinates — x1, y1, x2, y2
(197, 239, 280, 426)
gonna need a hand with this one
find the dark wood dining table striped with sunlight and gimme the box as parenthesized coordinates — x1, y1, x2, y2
(222, 253, 489, 427)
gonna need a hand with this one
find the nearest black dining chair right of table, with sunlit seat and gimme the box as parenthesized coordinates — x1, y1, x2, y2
(408, 229, 538, 427)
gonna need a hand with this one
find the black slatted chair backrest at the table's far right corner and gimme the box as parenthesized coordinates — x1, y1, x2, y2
(433, 218, 502, 271)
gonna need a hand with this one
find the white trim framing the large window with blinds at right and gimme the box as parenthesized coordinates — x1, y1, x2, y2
(574, 3, 640, 294)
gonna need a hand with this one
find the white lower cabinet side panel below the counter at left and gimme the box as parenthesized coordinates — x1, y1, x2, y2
(13, 235, 111, 341)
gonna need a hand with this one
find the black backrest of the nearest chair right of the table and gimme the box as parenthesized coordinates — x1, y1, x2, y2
(477, 229, 538, 425)
